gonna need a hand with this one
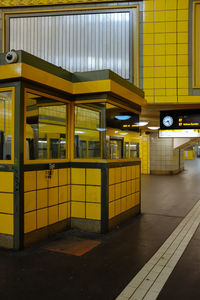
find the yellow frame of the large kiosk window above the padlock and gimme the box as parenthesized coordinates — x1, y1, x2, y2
(24, 88, 71, 165)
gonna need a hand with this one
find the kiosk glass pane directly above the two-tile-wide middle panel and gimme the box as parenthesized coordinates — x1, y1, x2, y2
(75, 103, 106, 158)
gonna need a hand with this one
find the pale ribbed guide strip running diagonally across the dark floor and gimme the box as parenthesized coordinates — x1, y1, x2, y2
(116, 200, 200, 300)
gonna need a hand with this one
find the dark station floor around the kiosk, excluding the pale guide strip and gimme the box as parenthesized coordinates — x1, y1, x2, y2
(0, 159, 200, 300)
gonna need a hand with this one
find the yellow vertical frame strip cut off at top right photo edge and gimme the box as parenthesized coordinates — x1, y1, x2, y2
(192, 1, 200, 89)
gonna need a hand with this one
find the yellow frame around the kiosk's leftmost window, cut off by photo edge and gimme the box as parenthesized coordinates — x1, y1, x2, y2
(0, 86, 15, 165)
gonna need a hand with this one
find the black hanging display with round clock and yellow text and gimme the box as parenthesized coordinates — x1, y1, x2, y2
(160, 109, 200, 130)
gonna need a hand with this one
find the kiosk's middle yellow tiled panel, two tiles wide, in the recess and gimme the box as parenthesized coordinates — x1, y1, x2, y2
(71, 168, 101, 220)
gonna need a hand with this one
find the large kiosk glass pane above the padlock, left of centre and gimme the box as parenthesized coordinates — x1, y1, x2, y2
(26, 93, 67, 160)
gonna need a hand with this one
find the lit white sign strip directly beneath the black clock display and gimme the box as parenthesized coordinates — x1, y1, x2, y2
(158, 129, 200, 138)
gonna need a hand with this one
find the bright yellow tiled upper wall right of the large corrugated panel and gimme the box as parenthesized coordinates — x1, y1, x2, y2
(143, 0, 189, 103)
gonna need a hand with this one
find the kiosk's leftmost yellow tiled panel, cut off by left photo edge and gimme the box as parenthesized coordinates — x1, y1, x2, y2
(0, 172, 14, 235)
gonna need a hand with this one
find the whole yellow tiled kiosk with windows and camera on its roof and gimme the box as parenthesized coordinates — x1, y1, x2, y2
(0, 51, 146, 249)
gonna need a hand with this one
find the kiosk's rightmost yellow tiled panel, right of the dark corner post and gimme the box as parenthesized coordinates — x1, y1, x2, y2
(108, 166, 140, 219)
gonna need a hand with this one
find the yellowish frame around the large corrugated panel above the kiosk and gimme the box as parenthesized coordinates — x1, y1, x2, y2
(2, 4, 140, 86)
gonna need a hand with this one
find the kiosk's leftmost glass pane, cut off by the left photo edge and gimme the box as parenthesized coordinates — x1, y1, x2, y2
(0, 91, 13, 160)
